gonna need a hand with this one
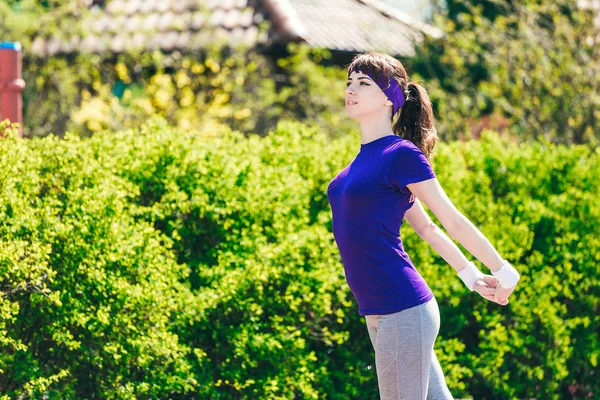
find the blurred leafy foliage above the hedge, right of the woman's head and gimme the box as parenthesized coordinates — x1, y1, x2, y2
(411, 0, 600, 144)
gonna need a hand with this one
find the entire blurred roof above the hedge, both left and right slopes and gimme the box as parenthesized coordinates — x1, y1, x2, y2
(30, 0, 439, 56)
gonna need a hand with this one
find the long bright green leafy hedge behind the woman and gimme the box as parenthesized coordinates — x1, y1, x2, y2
(0, 119, 600, 400)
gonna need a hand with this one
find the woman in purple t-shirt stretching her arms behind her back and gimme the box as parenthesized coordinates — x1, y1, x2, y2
(327, 53, 520, 400)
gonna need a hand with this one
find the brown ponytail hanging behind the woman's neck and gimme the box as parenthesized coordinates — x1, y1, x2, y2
(392, 82, 438, 160)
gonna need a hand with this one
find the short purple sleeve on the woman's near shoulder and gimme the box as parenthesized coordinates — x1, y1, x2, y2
(388, 143, 436, 189)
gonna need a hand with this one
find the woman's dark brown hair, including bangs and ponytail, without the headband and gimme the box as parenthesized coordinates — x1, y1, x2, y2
(348, 52, 438, 160)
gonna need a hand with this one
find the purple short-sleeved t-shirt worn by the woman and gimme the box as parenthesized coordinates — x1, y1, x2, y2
(327, 135, 436, 315)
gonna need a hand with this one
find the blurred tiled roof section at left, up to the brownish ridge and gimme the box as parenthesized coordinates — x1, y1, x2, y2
(30, 0, 264, 56)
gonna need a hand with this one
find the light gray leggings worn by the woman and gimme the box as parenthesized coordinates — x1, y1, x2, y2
(365, 297, 453, 400)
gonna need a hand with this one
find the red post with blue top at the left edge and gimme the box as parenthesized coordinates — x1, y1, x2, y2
(0, 42, 25, 137)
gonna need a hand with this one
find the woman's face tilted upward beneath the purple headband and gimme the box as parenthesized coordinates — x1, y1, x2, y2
(346, 71, 392, 120)
